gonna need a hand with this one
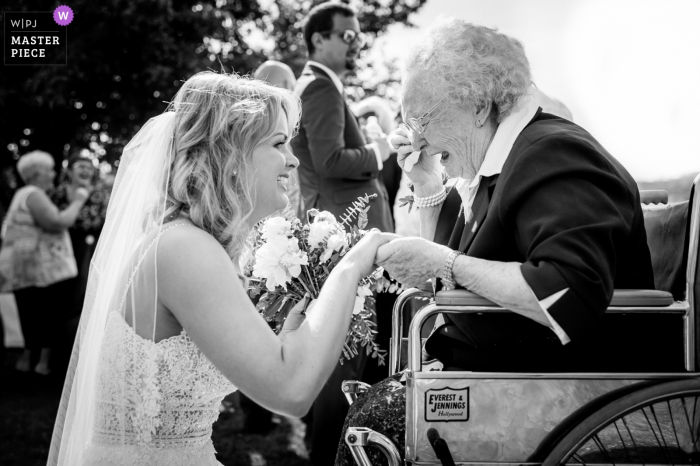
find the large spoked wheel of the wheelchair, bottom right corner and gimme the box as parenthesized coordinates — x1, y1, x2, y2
(542, 379, 700, 466)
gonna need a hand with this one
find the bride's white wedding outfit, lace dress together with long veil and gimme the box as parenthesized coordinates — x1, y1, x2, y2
(47, 114, 241, 466)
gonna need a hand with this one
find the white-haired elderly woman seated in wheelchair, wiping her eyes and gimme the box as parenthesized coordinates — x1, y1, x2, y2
(336, 19, 654, 465)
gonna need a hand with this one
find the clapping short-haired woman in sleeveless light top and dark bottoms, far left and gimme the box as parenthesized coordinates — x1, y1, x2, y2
(0, 151, 89, 375)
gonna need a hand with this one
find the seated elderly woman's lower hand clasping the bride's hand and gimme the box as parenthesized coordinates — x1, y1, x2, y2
(375, 238, 452, 287)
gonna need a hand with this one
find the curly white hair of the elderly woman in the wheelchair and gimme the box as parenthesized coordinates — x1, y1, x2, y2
(406, 18, 532, 123)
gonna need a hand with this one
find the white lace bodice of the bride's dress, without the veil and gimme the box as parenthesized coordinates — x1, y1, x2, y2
(84, 224, 236, 466)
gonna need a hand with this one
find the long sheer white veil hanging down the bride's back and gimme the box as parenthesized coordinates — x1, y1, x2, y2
(47, 108, 176, 466)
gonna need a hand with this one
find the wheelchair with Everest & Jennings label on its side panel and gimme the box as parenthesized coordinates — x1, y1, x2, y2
(342, 175, 700, 466)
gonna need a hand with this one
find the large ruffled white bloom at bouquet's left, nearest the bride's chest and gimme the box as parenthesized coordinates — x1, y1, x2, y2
(253, 235, 309, 291)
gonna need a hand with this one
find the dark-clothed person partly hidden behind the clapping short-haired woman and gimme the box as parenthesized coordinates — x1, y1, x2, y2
(51, 153, 109, 318)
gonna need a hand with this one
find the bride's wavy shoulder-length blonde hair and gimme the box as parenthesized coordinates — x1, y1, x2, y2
(165, 72, 301, 259)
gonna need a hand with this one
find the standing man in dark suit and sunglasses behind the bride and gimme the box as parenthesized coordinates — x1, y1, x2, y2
(291, 2, 394, 466)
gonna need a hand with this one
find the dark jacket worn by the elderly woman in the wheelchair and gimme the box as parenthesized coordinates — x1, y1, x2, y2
(435, 109, 654, 347)
